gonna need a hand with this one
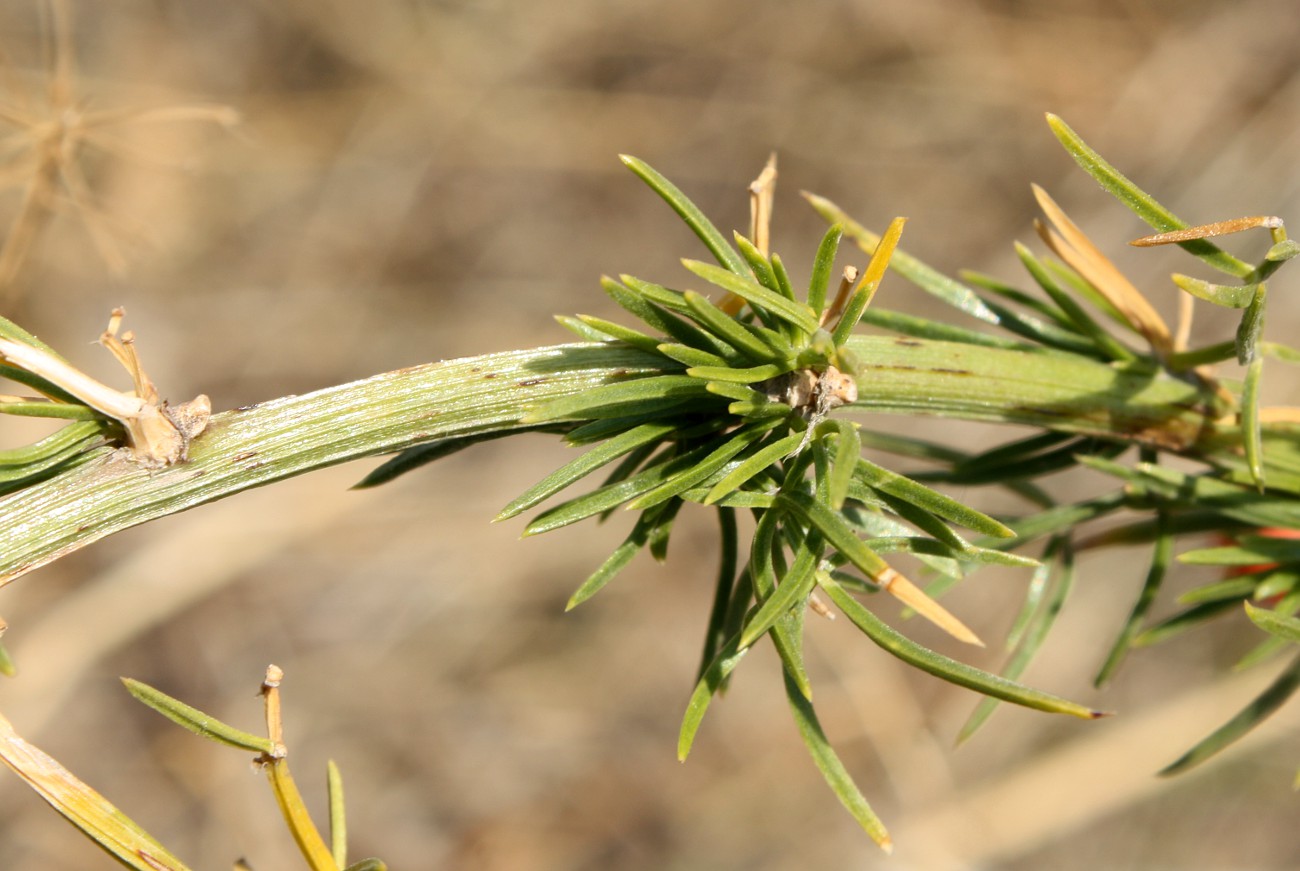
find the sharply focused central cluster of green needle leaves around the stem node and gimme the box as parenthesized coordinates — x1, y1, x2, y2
(372, 157, 1097, 846)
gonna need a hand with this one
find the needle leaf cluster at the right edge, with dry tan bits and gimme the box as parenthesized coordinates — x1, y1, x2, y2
(809, 116, 1300, 784)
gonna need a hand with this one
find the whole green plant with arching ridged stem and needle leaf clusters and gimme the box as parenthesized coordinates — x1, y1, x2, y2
(0, 116, 1300, 863)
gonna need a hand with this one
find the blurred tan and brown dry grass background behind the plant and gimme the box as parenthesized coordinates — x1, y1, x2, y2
(0, 0, 1300, 871)
